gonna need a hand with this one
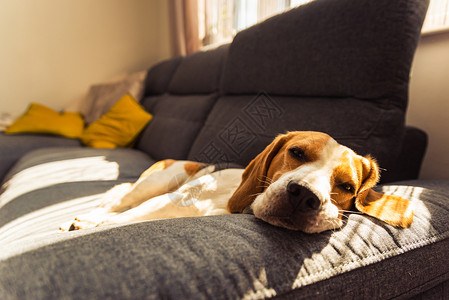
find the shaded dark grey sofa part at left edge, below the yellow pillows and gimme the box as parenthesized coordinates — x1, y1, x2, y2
(0, 132, 81, 182)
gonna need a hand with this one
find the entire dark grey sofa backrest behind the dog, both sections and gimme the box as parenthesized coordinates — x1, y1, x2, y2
(137, 0, 428, 176)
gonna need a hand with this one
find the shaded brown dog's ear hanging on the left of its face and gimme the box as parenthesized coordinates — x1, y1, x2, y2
(228, 134, 290, 213)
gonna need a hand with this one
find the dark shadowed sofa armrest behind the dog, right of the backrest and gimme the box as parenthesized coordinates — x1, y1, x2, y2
(382, 126, 428, 182)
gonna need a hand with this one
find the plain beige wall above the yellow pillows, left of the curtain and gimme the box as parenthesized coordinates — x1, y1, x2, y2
(0, 0, 170, 115)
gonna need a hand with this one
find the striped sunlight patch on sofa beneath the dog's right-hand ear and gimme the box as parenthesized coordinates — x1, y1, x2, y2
(291, 185, 428, 289)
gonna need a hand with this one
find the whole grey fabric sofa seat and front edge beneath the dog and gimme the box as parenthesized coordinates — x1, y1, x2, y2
(0, 149, 449, 299)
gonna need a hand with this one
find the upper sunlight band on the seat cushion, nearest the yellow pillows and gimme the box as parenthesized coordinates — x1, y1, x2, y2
(0, 156, 119, 207)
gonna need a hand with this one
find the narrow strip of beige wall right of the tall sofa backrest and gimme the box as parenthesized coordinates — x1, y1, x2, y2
(407, 32, 449, 179)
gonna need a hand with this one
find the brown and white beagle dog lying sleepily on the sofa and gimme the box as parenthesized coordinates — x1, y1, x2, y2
(61, 131, 413, 233)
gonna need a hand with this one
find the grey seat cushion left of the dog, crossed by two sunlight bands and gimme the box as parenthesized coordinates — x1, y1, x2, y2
(0, 147, 155, 243)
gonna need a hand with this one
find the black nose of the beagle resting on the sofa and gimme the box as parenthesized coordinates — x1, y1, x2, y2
(287, 181, 321, 212)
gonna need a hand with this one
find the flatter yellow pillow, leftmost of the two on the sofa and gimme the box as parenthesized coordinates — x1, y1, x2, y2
(5, 103, 84, 138)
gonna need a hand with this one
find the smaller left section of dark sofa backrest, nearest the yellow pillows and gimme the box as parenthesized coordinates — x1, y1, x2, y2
(136, 46, 228, 160)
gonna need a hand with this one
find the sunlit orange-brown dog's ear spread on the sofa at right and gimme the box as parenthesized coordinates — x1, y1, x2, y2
(355, 156, 413, 228)
